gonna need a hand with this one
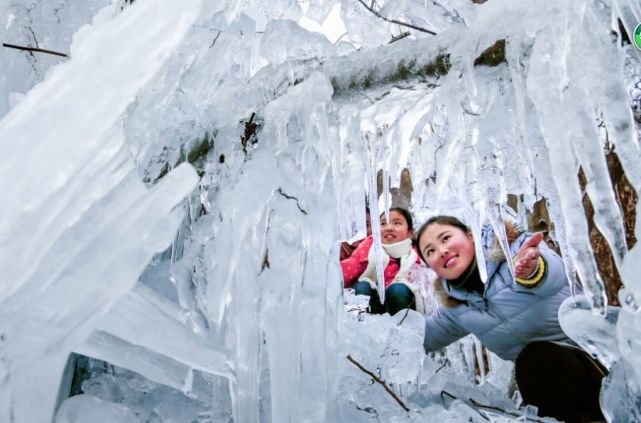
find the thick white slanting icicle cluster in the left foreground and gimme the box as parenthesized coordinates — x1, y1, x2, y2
(0, 1, 199, 422)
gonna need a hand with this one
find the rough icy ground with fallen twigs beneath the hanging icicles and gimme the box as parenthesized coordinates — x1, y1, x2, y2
(56, 291, 555, 423)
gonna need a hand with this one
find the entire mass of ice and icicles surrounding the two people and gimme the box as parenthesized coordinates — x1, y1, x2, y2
(0, 0, 641, 423)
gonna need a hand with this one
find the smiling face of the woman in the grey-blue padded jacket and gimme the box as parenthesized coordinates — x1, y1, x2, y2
(418, 223, 475, 280)
